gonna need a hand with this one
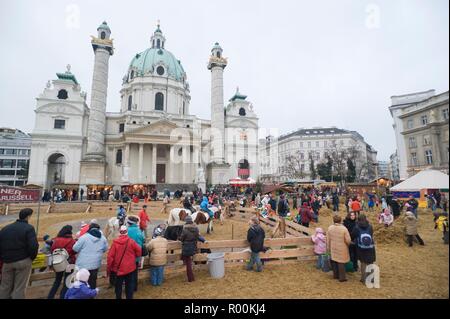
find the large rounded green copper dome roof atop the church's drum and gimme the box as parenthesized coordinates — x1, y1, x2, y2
(130, 47, 185, 81)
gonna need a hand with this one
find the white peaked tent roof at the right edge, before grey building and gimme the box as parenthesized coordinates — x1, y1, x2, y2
(391, 169, 448, 192)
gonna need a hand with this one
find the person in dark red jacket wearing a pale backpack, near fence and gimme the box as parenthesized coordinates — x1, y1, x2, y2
(47, 225, 76, 299)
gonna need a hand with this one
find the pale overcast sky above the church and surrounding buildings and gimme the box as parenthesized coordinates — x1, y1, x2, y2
(0, 0, 449, 160)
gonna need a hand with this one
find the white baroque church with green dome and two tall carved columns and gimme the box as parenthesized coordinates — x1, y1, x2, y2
(28, 22, 259, 195)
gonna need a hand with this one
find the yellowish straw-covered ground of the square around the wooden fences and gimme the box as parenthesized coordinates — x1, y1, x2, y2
(0, 202, 449, 299)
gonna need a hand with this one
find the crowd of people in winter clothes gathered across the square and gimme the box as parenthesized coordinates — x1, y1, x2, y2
(0, 188, 448, 299)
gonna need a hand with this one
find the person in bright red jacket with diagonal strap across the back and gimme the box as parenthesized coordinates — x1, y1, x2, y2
(107, 226, 142, 299)
